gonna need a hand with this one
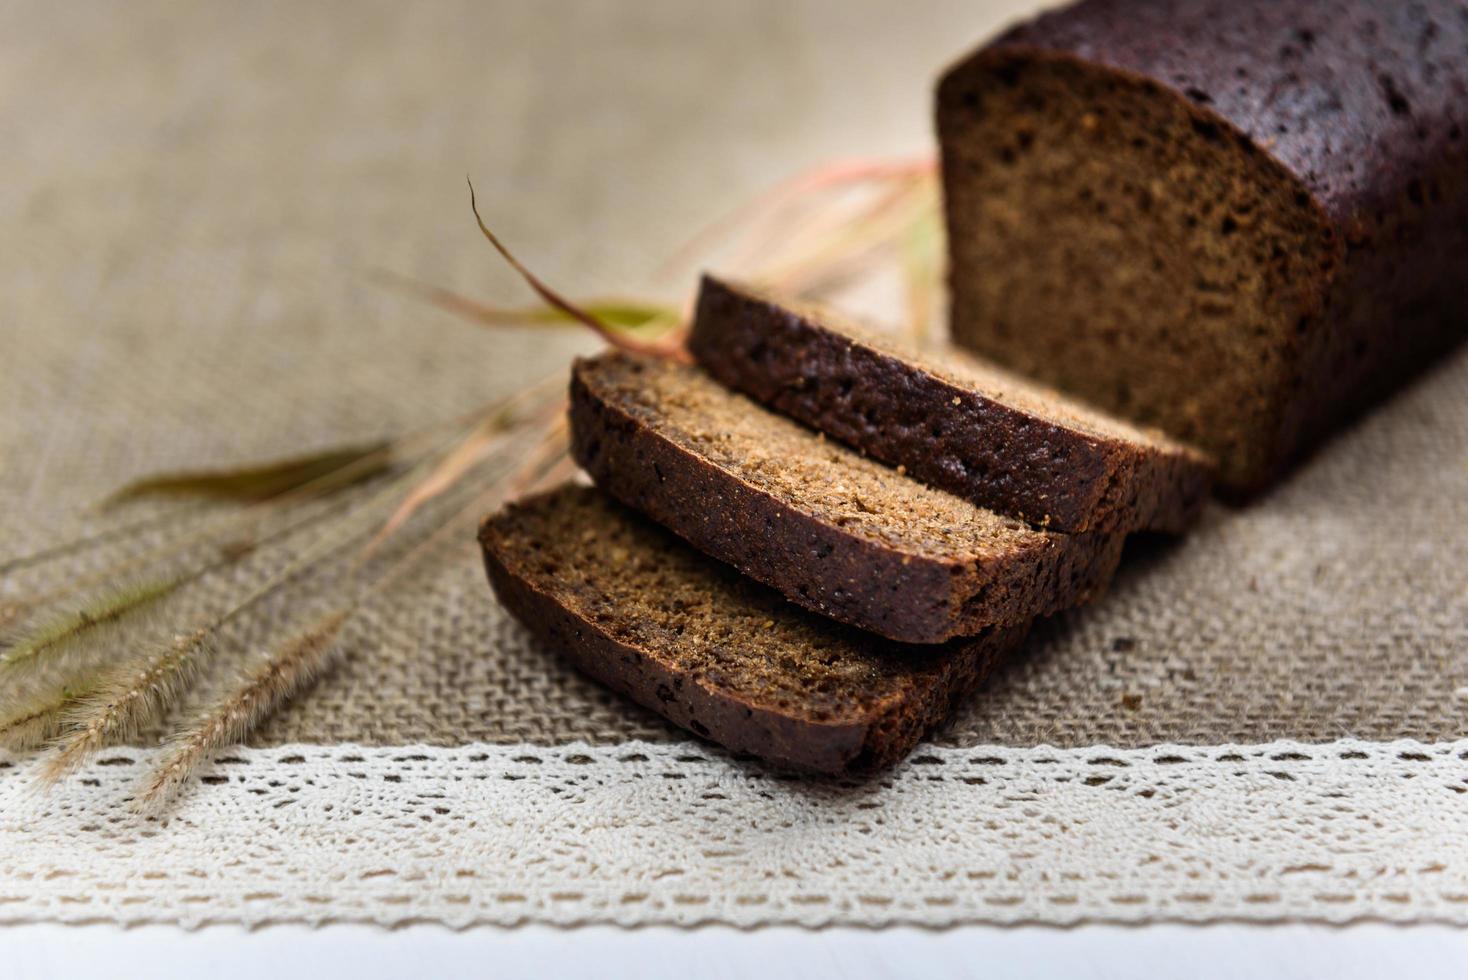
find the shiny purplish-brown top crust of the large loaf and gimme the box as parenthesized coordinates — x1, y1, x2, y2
(974, 0, 1468, 228)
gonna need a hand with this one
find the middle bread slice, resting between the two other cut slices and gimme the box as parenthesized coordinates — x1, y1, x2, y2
(571, 352, 1122, 643)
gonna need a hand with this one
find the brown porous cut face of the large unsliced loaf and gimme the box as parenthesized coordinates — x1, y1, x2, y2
(938, 45, 1334, 490)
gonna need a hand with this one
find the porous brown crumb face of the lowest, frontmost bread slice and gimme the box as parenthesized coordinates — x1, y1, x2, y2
(492, 487, 951, 722)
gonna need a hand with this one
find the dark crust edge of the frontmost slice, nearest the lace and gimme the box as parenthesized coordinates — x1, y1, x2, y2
(480, 492, 1028, 775)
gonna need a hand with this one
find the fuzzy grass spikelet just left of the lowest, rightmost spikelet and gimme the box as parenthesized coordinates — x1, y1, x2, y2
(41, 626, 216, 783)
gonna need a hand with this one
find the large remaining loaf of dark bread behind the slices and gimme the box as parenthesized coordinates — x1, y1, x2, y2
(937, 0, 1468, 491)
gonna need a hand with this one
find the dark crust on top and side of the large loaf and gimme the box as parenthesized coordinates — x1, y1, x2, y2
(938, 0, 1468, 496)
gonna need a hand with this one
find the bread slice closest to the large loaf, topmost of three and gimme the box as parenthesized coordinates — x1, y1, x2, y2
(688, 276, 1211, 531)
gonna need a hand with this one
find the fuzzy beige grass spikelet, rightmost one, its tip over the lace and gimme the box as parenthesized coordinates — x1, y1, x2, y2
(135, 609, 352, 810)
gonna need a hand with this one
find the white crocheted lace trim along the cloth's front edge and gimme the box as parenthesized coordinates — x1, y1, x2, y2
(0, 739, 1468, 927)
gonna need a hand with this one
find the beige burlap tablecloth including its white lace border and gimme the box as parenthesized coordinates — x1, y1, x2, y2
(0, 0, 1468, 926)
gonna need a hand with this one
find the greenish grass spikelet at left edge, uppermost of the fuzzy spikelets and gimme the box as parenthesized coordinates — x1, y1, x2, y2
(0, 577, 185, 680)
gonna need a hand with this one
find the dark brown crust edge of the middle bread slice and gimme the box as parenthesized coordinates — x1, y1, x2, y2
(571, 354, 1123, 643)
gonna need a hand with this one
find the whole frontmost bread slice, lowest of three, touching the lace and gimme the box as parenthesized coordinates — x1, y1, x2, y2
(480, 486, 1025, 773)
